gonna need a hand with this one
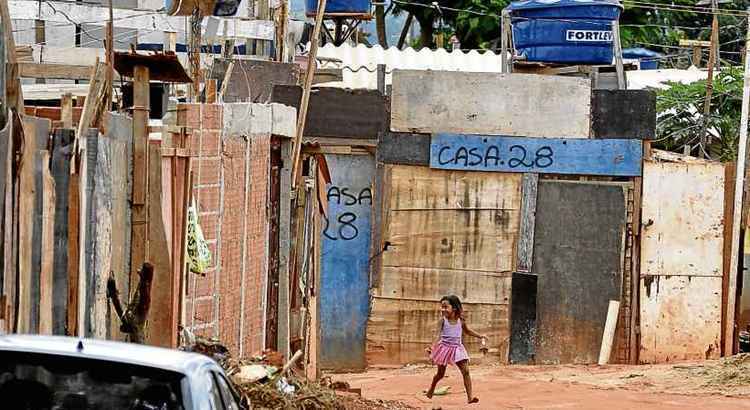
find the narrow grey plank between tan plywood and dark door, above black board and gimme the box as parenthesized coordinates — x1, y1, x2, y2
(516, 174, 539, 273)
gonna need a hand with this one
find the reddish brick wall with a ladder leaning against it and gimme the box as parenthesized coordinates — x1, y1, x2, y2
(177, 104, 270, 356)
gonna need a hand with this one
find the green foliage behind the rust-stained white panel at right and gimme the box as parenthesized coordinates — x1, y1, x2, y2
(655, 67, 743, 162)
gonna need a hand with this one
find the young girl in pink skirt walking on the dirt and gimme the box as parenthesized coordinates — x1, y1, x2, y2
(425, 295, 487, 404)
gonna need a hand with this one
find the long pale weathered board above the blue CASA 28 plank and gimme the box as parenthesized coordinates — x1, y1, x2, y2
(391, 70, 591, 138)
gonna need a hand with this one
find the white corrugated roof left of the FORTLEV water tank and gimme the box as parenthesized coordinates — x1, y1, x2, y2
(318, 43, 501, 89)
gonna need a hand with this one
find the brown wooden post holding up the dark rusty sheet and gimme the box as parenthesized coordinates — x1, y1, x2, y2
(130, 66, 150, 284)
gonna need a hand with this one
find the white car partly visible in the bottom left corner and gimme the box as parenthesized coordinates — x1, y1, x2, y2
(0, 335, 240, 410)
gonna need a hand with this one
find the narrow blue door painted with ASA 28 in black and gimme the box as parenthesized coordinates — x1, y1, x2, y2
(319, 155, 375, 370)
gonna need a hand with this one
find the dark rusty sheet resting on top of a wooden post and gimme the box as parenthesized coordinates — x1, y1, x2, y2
(115, 52, 193, 83)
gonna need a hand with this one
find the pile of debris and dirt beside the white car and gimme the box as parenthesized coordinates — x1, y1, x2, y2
(183, 337, 412, 410)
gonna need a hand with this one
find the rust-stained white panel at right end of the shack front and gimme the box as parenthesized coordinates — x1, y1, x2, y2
(639, 151, 725, 363)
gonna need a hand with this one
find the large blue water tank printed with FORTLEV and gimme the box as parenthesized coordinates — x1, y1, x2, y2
(508, 0, 622, 64)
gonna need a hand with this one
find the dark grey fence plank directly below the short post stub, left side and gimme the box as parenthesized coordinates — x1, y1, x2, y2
(51, 129, 74, 335)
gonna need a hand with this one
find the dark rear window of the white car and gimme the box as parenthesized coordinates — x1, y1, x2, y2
(0, 352, 184, 410)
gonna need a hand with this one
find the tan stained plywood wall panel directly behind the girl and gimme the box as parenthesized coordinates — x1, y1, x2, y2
(367, 165, 521, 365)
